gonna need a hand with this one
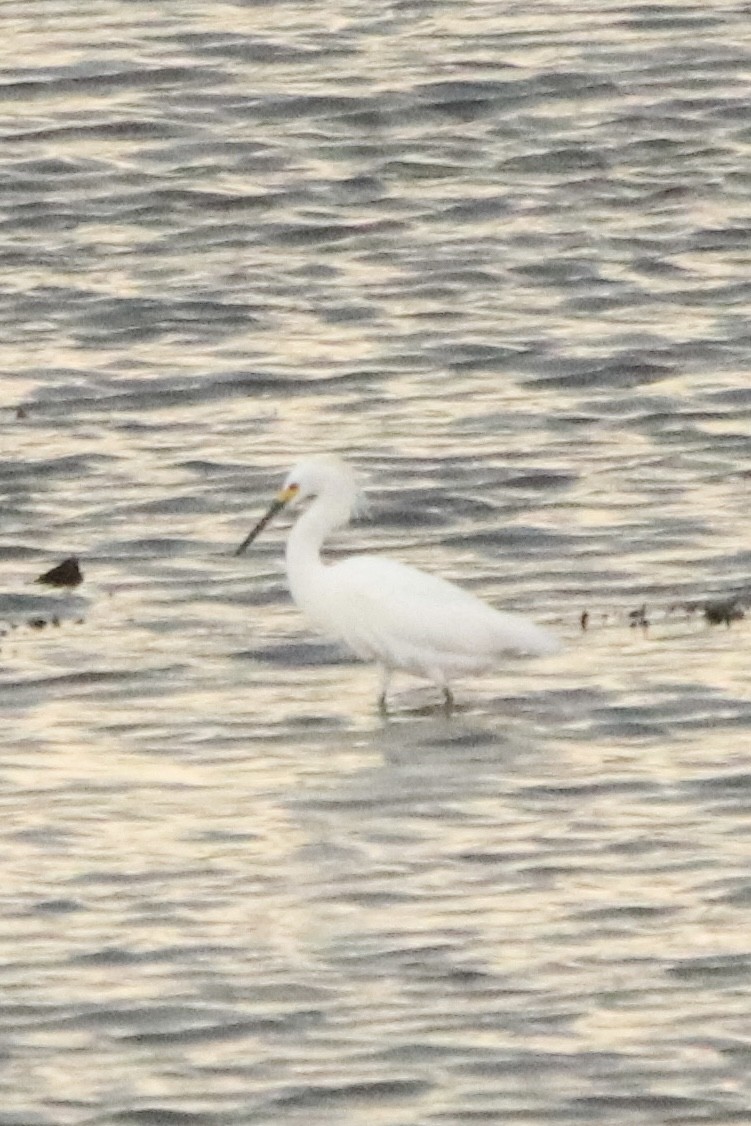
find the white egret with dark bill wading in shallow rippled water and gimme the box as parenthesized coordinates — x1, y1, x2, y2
(235, 454, 561, 712)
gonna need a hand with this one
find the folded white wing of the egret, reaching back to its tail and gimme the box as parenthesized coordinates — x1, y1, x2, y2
(329, 555, 558, 664)
